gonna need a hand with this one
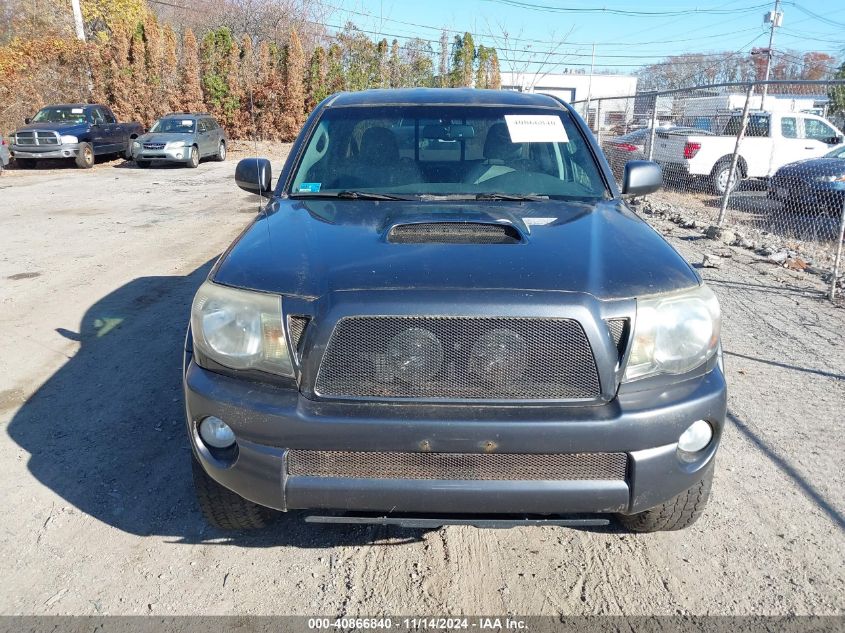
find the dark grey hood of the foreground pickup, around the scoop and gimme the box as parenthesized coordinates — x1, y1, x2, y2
(212, 199, 699, 299)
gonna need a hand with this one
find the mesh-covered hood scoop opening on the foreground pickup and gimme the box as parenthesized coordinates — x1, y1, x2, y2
(387, 221, 523, 244)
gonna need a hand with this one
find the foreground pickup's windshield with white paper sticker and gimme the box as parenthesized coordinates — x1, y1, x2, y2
(289, 106, 607, 200)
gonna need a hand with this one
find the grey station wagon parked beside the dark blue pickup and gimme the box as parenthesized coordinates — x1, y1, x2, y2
(132, 112, 228, 168)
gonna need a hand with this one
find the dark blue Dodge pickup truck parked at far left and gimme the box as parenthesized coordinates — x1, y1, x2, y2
(12, 103, 144, 169)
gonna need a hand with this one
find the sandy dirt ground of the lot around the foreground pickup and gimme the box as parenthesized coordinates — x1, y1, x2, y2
(0, 147, 845, 615)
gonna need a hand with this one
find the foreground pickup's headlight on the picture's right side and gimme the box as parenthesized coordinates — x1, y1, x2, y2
(623, 285, 721, 381)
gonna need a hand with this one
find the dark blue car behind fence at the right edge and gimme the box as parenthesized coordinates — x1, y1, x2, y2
(768, 147, 845, 215)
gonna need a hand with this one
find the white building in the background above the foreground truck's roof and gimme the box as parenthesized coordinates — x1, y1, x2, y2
(502, 72, 637, 129)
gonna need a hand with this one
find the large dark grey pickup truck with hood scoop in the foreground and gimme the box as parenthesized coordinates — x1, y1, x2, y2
(183, 89, 726, 531)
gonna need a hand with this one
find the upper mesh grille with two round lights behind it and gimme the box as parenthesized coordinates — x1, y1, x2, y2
(315, 316, 600, 401)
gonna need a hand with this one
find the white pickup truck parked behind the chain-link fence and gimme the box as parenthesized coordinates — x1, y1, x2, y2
(653, 111, 845, 194)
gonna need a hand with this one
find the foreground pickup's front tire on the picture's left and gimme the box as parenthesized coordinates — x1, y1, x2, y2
(191, 456, 276, 530)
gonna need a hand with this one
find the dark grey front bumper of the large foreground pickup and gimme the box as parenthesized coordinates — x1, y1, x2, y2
(184, 354, 727, 514)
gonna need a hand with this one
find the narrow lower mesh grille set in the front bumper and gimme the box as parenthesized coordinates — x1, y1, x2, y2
(288, 450, 628, 481)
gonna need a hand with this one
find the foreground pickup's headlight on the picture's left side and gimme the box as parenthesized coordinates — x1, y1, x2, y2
(191, 281, 293, 376)
